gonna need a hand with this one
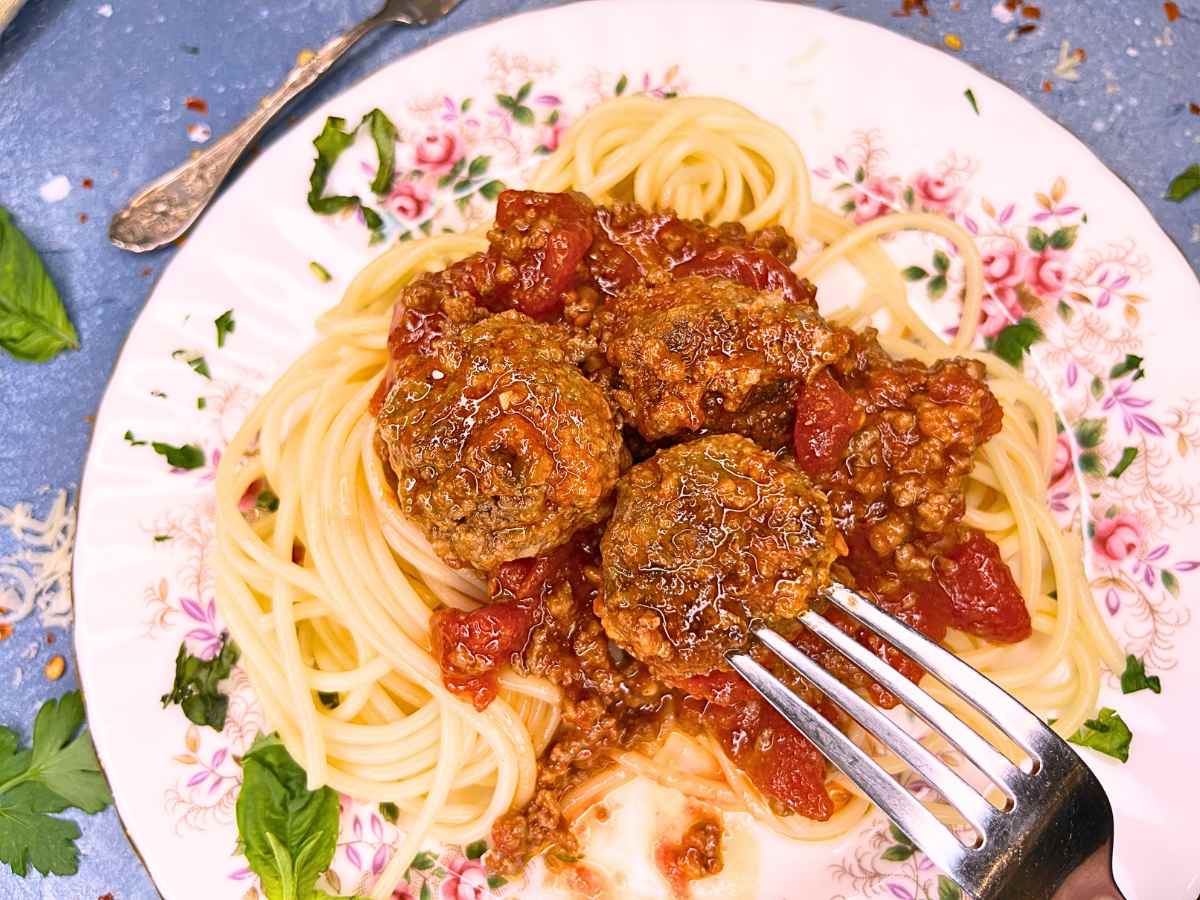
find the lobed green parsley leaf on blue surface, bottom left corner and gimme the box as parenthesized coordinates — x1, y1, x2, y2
(0, 691, 113, 877)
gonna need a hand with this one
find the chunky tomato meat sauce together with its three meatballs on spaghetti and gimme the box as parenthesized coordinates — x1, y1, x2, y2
(372, 191, 1030, 872)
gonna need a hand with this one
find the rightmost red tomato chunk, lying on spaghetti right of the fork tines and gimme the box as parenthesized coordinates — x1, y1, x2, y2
(934, 528, 1033, 643)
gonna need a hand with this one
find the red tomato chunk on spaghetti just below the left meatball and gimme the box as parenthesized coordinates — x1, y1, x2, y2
(430, 601, 534, 710)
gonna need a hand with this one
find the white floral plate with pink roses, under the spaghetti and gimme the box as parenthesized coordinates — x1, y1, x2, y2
(74, 0, 1200, 900)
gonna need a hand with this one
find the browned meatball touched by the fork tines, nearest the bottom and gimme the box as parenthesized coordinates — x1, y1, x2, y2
(596, 434, 844, 680)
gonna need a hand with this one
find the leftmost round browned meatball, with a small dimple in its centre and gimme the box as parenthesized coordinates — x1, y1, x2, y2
(378, 311, 624, 572)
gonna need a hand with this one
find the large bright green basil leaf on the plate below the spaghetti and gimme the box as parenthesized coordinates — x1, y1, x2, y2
(238, 736, 338, 900)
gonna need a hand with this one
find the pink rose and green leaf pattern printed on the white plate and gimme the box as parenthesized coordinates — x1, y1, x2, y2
(131, 65, 1200, 900)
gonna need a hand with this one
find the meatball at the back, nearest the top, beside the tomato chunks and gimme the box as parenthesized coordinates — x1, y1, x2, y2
(596, 276, 850, 449)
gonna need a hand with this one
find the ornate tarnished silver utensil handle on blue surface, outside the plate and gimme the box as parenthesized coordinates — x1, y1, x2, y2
(108, 0, 462, 253)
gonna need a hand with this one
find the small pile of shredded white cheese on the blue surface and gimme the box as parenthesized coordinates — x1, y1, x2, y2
(0, 491, 76, 628)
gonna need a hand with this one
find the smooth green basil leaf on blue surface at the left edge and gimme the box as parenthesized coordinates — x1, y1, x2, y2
(0, 208, 79, 362)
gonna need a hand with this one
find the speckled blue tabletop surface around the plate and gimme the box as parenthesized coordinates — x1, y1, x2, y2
(0, 0, 1200, 900)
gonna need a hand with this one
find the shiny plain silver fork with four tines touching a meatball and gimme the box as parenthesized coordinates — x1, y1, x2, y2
(728, 584, 1123, 900)
